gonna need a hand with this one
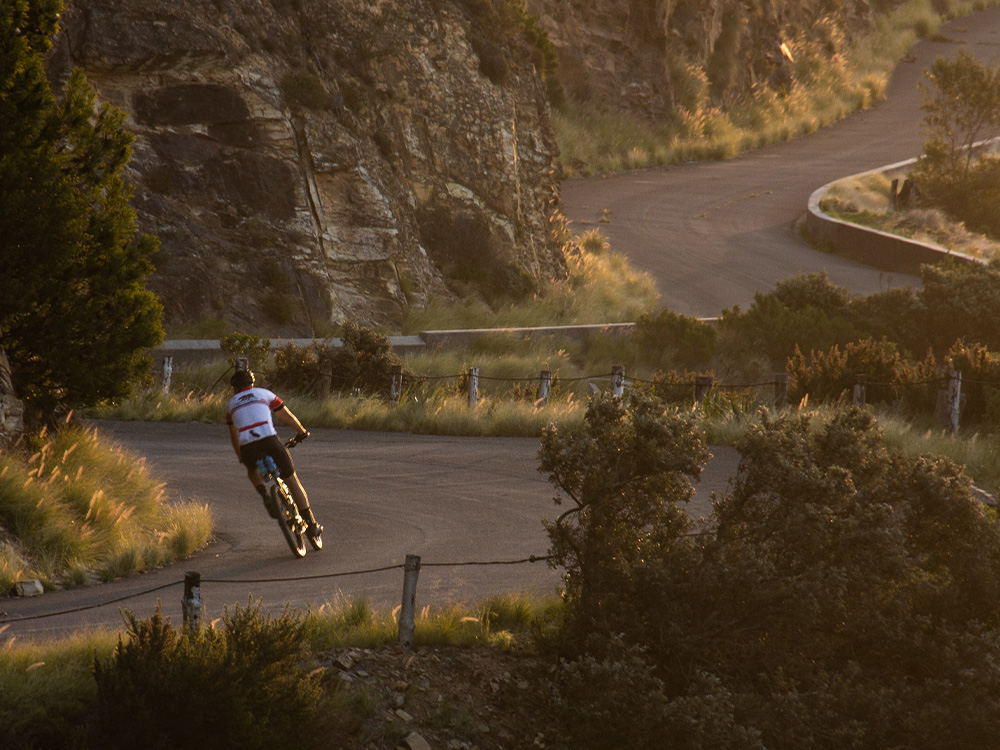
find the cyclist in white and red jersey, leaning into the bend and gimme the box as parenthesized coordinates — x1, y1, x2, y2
(226, 370, 323, 539)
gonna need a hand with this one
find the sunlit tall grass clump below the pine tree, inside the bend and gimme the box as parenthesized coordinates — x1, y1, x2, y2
(0, 425, 212, 591)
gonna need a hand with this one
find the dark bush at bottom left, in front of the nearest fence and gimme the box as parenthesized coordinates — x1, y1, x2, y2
(92, 605, 332, 750)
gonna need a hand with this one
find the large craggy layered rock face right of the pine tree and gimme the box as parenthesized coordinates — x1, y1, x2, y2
(50, 0, 564, 335)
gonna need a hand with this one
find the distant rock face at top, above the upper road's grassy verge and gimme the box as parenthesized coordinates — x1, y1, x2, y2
(527, 0, 899, 120)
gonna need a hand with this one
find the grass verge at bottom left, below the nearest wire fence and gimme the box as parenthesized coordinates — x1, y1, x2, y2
(0, 594, 563, 750)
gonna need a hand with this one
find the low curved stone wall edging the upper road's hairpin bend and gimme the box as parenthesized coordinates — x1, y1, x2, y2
(806, 159, 986, 274)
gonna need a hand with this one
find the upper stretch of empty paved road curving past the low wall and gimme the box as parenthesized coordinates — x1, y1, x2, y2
(562, 9, 1000, 316)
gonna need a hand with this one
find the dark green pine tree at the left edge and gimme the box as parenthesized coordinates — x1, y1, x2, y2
(0, 0, 163, 417)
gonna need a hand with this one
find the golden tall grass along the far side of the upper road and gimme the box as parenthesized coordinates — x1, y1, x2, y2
(553, 0, 997, 177)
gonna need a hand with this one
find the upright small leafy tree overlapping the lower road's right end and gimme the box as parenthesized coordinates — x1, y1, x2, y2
(539, 389, 708, 648)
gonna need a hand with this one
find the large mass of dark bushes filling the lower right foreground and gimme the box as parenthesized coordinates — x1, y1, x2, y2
(541, 400, 1000, 750)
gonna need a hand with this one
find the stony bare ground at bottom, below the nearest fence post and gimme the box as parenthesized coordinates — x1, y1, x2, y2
(323, 647, 556, 750)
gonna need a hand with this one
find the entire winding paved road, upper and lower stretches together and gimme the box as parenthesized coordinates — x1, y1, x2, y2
(7, 9, 1000, 642)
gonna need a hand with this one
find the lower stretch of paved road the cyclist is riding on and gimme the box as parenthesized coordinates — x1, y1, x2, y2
(0, 422, 737, 642)
